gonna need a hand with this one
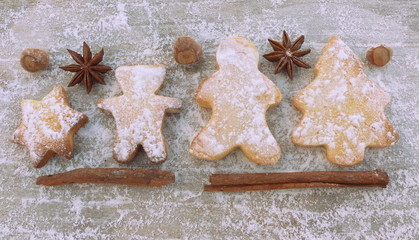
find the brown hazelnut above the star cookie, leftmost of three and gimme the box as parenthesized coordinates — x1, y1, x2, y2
(20, 48, 49, 72)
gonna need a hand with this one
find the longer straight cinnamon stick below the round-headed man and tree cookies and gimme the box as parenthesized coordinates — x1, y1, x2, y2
(204, 170, 389, 192)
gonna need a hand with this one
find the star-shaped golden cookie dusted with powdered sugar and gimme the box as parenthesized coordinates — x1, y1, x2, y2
(12, 86, 88, 168)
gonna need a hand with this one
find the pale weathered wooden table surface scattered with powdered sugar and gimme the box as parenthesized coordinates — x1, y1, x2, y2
(0, 0, 419, 239)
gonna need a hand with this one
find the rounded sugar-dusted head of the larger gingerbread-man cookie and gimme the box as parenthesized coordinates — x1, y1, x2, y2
(216, 38, 259, 69)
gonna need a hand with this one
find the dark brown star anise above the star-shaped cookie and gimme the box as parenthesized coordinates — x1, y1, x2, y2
(60, 42, 112, 93)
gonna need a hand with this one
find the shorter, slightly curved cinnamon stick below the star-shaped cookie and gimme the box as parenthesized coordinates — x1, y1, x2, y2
(36, 168, 175, 186)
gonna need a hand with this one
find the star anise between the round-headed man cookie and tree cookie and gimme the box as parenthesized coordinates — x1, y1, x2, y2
(263, 31, 311, 79)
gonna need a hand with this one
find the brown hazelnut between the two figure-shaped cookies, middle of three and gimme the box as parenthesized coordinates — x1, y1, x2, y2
(173, 37, 202, 64)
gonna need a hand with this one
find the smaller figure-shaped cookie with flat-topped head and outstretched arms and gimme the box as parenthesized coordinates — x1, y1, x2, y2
(98, 65, 182, 163)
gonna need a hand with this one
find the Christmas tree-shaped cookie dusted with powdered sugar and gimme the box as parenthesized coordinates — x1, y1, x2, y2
(292, 36, 399, 166)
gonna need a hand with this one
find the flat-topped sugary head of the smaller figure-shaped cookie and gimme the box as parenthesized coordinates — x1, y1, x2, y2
(115, 65, 166, 93)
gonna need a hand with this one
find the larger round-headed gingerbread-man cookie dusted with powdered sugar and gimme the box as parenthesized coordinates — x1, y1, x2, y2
(189, 38, 281, 164)
